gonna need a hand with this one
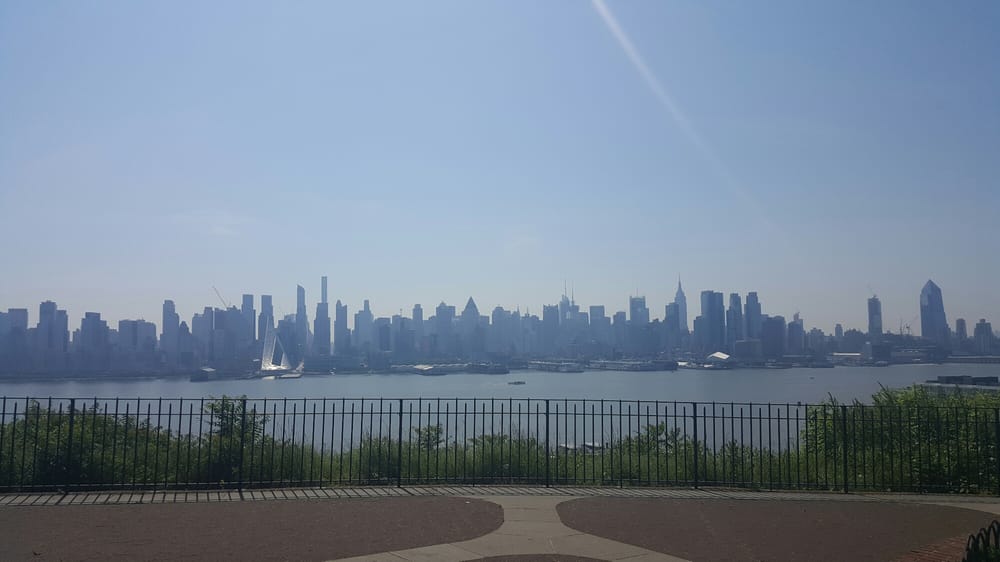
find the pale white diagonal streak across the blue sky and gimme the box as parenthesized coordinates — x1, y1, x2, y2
(591, 0, 775, 227)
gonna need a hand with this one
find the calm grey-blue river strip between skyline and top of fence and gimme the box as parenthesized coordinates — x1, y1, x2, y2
(0, 364, 1000, 404)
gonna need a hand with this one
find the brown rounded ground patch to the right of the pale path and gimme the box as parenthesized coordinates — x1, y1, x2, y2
(556, 498, 993, 562)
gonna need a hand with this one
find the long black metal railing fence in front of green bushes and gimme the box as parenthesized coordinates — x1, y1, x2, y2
(0, 397, 1000, 494)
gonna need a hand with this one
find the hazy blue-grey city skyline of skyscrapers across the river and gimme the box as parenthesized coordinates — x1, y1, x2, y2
(0, 277, 1000, 374)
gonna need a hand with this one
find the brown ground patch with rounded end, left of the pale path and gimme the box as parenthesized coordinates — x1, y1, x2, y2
(0, 497, 503, 560)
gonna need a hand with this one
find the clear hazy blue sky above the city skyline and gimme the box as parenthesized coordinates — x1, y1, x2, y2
(0, 0, 1000, 332)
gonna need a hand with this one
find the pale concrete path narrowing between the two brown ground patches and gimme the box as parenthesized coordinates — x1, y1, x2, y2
(336, 496, 684, 562)
